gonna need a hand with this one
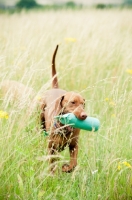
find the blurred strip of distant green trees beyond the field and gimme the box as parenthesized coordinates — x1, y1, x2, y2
(0, 0, 132, 9)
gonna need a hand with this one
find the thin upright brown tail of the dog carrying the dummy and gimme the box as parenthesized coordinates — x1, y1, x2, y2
(52, 45, 59, 88)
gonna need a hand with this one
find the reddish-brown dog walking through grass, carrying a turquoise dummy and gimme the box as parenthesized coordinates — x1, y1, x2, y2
(41, 45, 87, 172)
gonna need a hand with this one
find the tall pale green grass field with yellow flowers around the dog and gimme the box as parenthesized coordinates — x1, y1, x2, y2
(0, 10, 132, 200)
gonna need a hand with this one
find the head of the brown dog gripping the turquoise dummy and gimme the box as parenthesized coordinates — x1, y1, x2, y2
(55, 92, 87, 120)
